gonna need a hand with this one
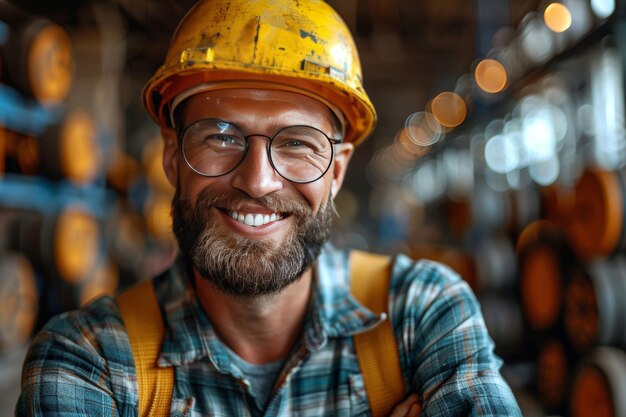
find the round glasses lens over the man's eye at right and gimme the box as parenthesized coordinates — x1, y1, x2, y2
(270, 126, 332, 182)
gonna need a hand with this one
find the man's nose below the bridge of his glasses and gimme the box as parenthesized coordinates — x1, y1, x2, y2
(231, 136, 283, 198)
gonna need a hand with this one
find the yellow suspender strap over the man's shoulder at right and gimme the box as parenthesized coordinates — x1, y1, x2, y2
(350, 251, 404, 417)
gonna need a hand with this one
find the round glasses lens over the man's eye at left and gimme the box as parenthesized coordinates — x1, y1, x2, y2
(183, 119, 246, 177)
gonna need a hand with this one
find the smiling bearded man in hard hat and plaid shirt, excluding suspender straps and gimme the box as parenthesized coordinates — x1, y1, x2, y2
(17, 0, 519, 416)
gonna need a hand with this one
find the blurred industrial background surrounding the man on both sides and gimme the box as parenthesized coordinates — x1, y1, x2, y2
(0, 0, 626, 417)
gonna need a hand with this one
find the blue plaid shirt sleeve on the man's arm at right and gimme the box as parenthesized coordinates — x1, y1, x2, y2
(391, 262, 521, 417)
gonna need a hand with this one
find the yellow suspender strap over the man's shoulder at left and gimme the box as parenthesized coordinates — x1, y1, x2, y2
(117, 280, 174, 417)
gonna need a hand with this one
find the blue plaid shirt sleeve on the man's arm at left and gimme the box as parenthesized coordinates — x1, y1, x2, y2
(15, 296, 132, 417)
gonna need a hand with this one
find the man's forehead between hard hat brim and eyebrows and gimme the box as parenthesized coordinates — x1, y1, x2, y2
(181, 89, 333, 130)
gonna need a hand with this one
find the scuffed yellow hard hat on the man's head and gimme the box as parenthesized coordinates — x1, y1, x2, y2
(143, 0, 376, 143)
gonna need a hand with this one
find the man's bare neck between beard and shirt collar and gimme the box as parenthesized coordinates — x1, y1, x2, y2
(194, 269, 313, 364)
